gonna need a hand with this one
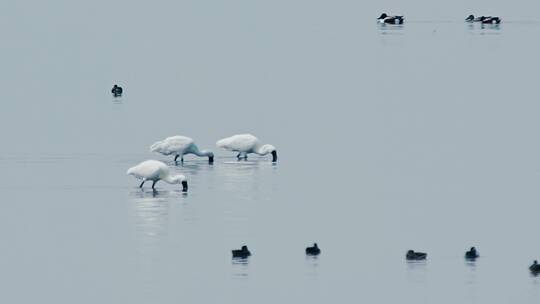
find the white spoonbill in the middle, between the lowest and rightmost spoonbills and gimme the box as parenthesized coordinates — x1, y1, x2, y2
(150, 136, 214, 163)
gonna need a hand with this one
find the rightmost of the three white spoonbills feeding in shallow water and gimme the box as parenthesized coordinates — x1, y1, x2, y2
(216, 134, 277, 162)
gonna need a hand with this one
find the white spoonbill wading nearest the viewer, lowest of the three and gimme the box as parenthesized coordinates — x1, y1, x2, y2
(127, 160, 187, 192)
